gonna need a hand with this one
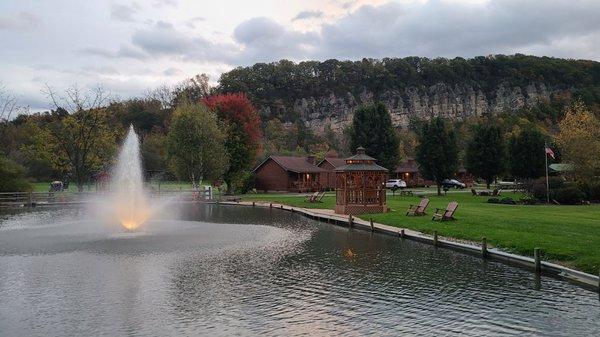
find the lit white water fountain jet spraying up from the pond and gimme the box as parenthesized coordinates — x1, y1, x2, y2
(109, 125, 151, 231)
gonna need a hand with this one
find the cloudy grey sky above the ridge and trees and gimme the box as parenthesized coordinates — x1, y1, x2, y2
(0, 0, 600, 111)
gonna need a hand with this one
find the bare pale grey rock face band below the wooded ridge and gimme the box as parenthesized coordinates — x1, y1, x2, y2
(263, 83, 558, 133)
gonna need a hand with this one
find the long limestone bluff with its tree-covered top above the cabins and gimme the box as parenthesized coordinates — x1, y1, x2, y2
(217, 54, 600, 133)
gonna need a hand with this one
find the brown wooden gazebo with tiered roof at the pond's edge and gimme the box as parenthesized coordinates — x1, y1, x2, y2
(334, 147, 388, 214)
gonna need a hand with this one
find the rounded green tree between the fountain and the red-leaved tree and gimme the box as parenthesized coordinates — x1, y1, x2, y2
(167, 102, 229, 188)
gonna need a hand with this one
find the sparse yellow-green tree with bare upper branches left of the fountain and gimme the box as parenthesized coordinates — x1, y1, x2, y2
(37, 86, 118, 191)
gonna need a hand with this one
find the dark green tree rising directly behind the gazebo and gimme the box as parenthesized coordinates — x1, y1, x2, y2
(349, 103, 400, 170)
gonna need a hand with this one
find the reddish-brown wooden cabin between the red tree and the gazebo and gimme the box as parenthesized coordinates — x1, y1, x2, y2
(253, 156, 327, 192)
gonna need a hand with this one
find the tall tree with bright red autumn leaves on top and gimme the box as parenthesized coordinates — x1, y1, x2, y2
(204, 93, 262, 194)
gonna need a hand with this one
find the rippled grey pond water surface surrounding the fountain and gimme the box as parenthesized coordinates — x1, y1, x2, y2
(0, 206, 600, 336)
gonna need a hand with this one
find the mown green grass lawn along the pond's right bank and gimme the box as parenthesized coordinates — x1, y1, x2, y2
(243, 192, 600, 275)
